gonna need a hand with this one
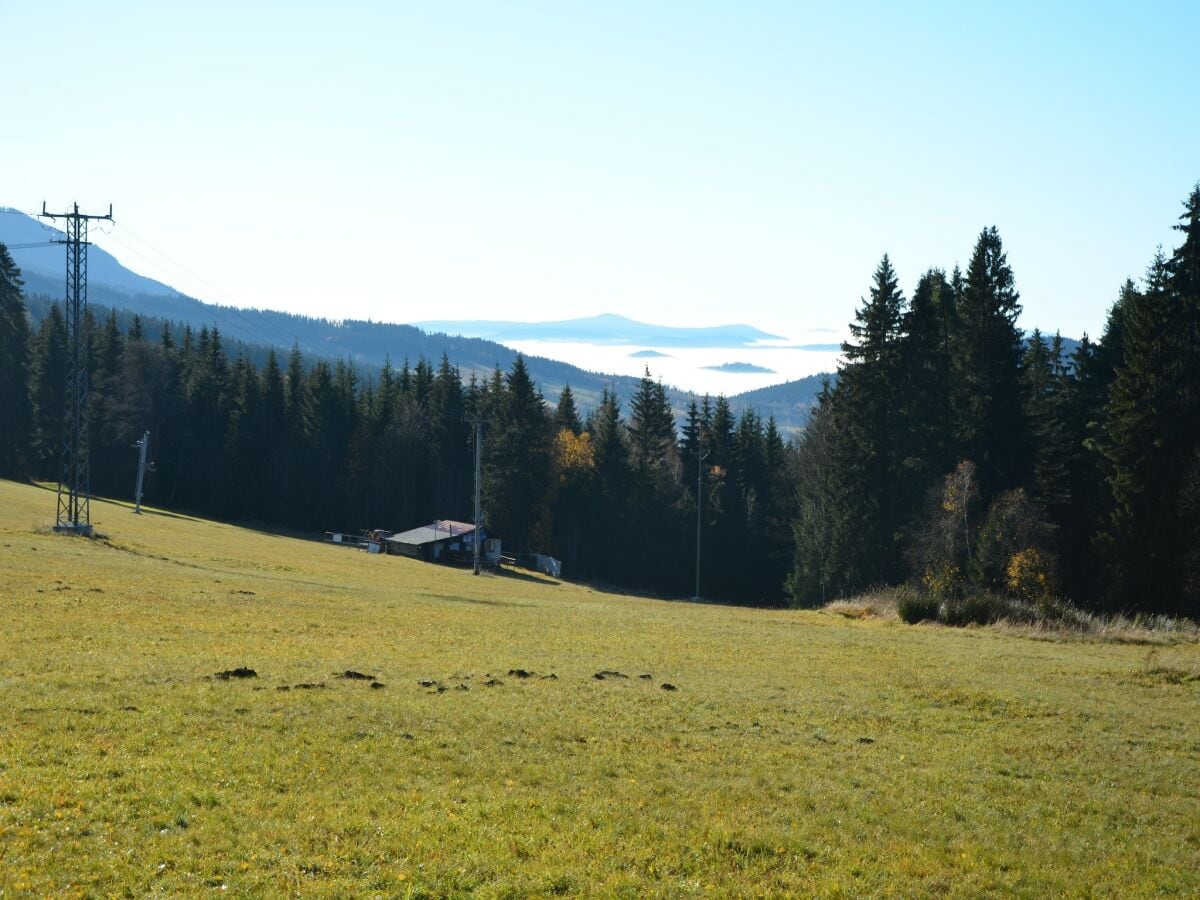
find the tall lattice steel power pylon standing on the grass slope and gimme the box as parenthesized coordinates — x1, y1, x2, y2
(42, 203, 113, 535)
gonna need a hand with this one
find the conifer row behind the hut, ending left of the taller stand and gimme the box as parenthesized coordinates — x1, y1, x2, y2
(0, 254, 792, 605)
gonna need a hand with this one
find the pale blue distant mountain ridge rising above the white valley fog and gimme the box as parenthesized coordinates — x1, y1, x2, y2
(413, 313, 784, 348)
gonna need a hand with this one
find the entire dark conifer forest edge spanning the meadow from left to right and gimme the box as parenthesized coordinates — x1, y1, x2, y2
(0, 187, 1200, 620)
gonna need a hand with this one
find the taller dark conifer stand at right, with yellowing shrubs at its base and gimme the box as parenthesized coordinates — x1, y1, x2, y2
(788, 186, 1200, 619)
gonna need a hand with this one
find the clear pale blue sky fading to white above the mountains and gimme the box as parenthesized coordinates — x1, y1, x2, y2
(0, 0, 1200, 335)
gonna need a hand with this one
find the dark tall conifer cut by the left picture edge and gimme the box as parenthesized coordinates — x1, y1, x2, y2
(0, 244, 34, 478)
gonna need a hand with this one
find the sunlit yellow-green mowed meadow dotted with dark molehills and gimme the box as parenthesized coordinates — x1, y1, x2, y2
(0, 482, 1200, 896)
